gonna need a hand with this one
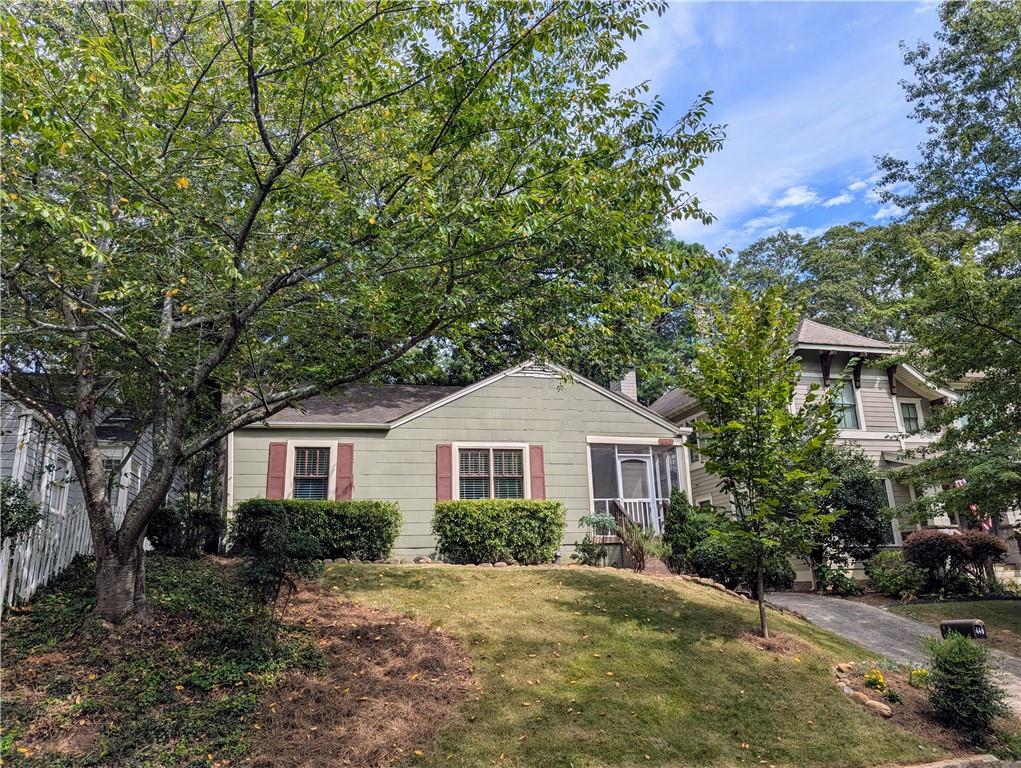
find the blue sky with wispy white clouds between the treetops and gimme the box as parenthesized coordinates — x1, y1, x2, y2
(613, 2, 938, 255)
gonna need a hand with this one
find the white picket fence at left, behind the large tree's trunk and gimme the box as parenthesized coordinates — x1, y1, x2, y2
(0, 505, 117, 613)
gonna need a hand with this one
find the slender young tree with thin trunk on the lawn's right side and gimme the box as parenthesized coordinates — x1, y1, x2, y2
(679, 289, 836, 637)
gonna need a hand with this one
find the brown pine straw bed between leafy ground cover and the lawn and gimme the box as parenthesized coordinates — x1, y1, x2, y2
(250, 585, 471, 768)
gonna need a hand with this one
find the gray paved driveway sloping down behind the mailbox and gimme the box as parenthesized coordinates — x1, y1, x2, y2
(769, 592, 1021, 716)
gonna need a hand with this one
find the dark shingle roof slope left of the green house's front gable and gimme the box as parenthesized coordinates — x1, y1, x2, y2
(259, 384, 460, 426)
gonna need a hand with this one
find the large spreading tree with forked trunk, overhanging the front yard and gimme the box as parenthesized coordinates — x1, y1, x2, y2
(0, 0, 722, 622)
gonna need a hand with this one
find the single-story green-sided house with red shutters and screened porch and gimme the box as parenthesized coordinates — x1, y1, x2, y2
(224, 363, 690, 557)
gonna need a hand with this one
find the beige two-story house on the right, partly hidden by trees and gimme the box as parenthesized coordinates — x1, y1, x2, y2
(650, 320, 1021, 582)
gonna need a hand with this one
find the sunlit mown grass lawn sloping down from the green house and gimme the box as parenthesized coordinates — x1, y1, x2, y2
(324, 565, 939, 768)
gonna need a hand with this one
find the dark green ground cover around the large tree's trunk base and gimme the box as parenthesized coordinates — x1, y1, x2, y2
(0, 556, 324, 766)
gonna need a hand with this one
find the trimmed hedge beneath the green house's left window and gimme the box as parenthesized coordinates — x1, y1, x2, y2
(234, 498, 401, 560)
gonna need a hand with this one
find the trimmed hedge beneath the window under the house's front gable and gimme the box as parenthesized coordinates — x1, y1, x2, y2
(433, 498, 567, 565)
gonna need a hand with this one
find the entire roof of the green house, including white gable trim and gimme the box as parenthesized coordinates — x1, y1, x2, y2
(244, 361, 679, 434)
